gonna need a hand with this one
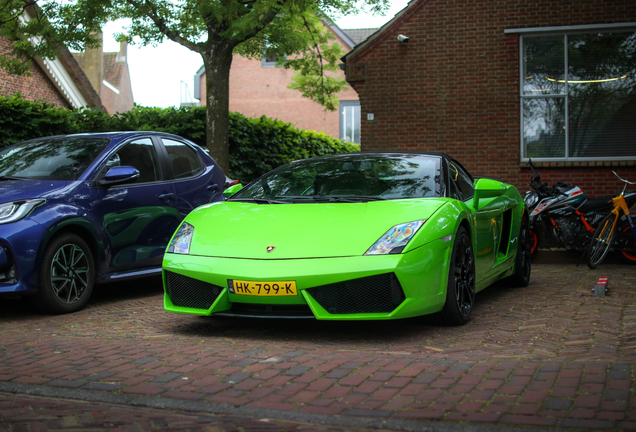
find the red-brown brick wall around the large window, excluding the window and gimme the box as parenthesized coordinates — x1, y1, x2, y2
(347, 0, 636, 196)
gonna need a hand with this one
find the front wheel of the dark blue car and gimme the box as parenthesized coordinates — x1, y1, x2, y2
(33, 233, 95, 314)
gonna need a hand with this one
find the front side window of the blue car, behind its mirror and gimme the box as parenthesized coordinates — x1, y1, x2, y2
(106, 138, 161, 184)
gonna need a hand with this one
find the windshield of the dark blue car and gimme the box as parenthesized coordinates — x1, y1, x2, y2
(0, 137, 109, 181)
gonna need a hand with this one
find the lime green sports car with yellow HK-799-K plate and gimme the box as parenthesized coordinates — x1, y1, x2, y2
(163, 152, 531, 325)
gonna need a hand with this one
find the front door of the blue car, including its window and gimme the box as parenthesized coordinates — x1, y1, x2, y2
(96, 138, 182, 272)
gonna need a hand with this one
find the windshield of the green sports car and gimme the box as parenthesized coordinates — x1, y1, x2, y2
(232, 153, 441, 203)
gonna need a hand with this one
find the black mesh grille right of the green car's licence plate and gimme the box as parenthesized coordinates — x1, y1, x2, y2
(307, 273, 405, 314)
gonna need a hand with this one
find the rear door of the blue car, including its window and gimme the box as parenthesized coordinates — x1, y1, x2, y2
(159, 137, 225, 217)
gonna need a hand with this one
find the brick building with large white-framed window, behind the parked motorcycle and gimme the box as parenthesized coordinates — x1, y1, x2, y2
(343, 0, 636, 197)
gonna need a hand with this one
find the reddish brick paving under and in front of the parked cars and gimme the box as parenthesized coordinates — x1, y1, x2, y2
(0, 265, 636, 432)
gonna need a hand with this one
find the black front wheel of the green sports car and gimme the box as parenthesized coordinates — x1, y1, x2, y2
(435, 227, 475, 326)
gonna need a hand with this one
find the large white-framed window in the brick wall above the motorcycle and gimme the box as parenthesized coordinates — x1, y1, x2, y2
(520, 30, 636, 161)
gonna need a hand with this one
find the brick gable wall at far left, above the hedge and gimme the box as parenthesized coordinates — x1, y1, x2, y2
(0, 38, 71, 108)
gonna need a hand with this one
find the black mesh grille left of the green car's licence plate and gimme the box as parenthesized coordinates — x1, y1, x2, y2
(166, 272, 223, 309)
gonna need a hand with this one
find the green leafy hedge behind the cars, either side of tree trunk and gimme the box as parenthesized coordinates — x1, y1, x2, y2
(0, 94, 358, 183)
